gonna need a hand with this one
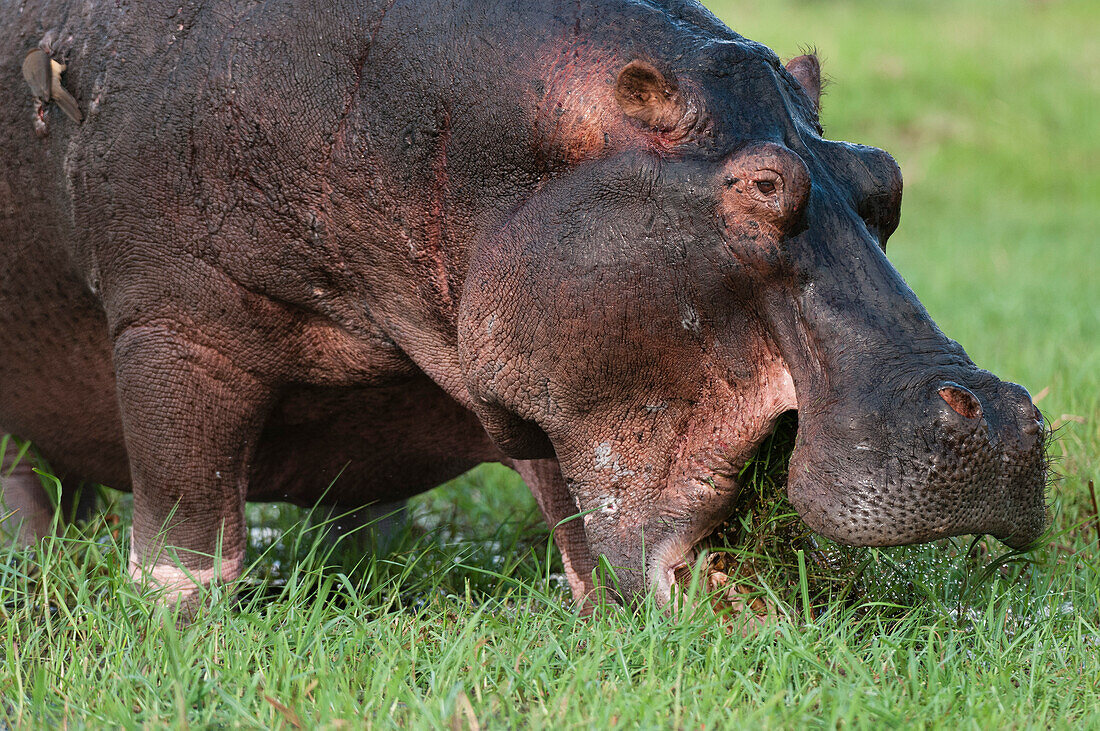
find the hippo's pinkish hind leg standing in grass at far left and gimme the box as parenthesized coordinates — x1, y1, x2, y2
(0, 434, 96, 546)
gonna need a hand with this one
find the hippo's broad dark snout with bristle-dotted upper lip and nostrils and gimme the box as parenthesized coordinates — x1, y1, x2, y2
(788, 372, 1047, 547)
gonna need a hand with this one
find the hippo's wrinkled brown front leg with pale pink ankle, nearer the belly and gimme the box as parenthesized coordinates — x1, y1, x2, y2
(114, 324, 272, 607)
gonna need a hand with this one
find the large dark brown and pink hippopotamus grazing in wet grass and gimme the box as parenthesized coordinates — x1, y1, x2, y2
(0, 0, 1047, 602)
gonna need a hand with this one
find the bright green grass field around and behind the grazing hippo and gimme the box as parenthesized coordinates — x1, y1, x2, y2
(0, 0, 1100, 729)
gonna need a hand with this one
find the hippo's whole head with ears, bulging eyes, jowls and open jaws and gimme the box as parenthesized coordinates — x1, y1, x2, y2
(459, 38, 1046, 598)
